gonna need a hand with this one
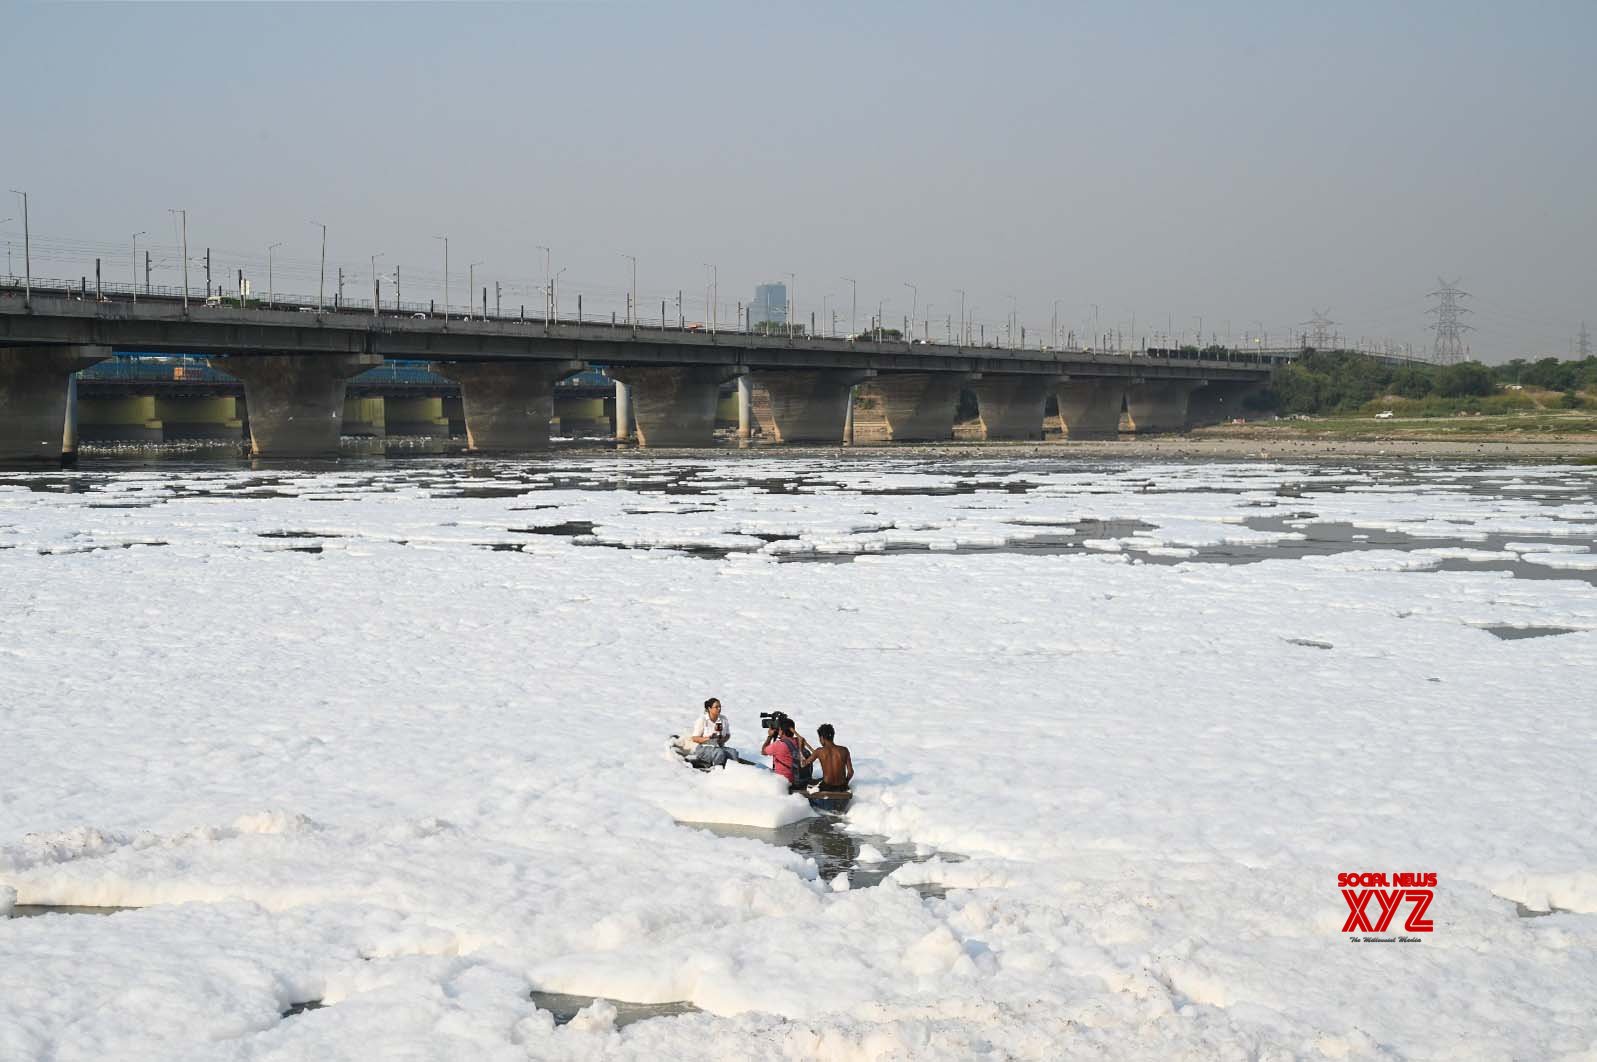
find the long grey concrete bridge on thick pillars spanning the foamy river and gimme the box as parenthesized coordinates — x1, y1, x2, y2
(0, 289, 1287, 460)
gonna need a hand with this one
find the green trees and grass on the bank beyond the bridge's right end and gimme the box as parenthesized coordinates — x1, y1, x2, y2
(1249, 350, 1597, 417)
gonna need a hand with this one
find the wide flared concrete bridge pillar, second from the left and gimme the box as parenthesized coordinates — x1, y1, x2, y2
(211, 355, 382, 457)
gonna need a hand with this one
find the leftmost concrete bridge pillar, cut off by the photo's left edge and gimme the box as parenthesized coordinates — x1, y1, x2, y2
(0, 347, 110, 462)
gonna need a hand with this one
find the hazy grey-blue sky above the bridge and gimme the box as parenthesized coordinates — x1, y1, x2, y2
(0, 0, 1597, 359)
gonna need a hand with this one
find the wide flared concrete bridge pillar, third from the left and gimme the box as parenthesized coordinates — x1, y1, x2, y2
(438, 361, 586, 450)
